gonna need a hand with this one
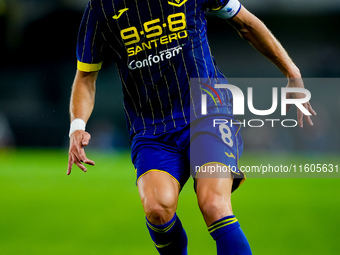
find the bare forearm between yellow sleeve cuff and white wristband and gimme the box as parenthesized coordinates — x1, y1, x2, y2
(70, 71, 98, 122)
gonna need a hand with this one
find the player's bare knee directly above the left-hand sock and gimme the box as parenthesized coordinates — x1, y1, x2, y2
(143, 194, 177, 225)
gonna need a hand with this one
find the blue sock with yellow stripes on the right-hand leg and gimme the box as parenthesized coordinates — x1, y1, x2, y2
(208, 215, 252, 255)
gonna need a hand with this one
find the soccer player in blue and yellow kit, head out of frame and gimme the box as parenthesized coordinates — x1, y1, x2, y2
(67, 0, 315, 255)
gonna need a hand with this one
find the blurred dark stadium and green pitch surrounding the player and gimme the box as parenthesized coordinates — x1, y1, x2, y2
(0, 0, 340, 255)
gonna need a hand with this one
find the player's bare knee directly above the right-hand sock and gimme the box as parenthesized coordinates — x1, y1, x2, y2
(198, 195, 233, 226)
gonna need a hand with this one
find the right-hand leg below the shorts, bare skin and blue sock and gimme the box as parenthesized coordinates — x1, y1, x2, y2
(196, 163, 251, 255)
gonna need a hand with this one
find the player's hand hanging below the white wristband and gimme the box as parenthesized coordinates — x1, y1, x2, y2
(67, 130, 95, 175)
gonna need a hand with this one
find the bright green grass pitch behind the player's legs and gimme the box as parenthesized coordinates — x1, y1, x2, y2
(0, 149, 340, 255)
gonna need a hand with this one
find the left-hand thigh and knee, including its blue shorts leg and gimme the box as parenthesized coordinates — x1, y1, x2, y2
(132, 136, 189, 225)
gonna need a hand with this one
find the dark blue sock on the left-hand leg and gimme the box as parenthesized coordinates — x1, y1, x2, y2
(146, 214, 188, 255)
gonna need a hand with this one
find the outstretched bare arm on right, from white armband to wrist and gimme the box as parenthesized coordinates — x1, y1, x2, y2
(230, 7, 301, 78)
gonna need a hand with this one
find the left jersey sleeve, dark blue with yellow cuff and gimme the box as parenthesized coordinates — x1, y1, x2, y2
(77, 4, 104, 72)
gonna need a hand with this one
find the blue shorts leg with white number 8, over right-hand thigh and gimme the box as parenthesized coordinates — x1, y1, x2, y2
(190, 117, 244, 191)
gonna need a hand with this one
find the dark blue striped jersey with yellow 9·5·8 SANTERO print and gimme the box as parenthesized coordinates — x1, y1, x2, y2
(77, 0, 238, 136)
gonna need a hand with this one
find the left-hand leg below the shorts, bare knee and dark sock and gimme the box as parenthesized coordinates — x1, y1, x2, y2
(138, 171, 188, 255)
